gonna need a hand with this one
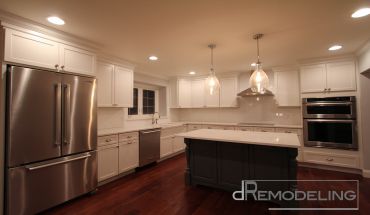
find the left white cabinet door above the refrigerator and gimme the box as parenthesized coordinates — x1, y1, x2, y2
(4, 29, 59, 69)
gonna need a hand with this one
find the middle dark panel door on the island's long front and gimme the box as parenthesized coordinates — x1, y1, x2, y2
(218, 143, 249, 191)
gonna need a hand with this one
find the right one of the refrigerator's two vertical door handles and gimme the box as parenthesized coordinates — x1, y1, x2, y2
(63, 84, 71, 144)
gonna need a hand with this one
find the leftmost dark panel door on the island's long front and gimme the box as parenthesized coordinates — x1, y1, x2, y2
(190, 140, 217, 185)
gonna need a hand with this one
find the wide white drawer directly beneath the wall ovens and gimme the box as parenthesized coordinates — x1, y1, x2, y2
(303, 151, 359, 168)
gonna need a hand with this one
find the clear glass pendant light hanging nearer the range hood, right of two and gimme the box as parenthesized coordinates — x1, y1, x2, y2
(249, 34, 269, 94)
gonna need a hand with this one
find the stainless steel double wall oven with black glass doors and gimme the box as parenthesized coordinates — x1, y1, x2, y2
(302, 96, 358, 149)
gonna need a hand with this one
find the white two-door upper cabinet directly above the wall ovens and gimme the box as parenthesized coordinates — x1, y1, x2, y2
(300, 60, 356, 93)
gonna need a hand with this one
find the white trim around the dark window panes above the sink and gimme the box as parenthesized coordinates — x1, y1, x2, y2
(126, 87, 159, 120)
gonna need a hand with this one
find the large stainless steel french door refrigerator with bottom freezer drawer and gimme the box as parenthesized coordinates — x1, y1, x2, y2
(6, 65, 97, 214)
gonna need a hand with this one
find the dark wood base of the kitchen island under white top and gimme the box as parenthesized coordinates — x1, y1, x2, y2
(185, 138, 298, 207)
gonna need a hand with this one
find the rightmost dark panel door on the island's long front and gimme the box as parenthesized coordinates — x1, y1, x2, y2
(249, 145, 296, 191)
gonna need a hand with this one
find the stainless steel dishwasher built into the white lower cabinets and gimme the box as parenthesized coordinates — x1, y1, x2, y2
(139, 129, 161, 167)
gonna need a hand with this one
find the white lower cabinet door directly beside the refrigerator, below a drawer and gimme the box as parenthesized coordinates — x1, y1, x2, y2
(98, 144, 118, 181)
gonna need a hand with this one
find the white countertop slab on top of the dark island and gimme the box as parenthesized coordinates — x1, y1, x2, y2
(176, 129, 300, 148)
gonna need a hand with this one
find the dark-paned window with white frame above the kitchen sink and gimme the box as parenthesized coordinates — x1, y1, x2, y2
(127, 86, 159, 119)
